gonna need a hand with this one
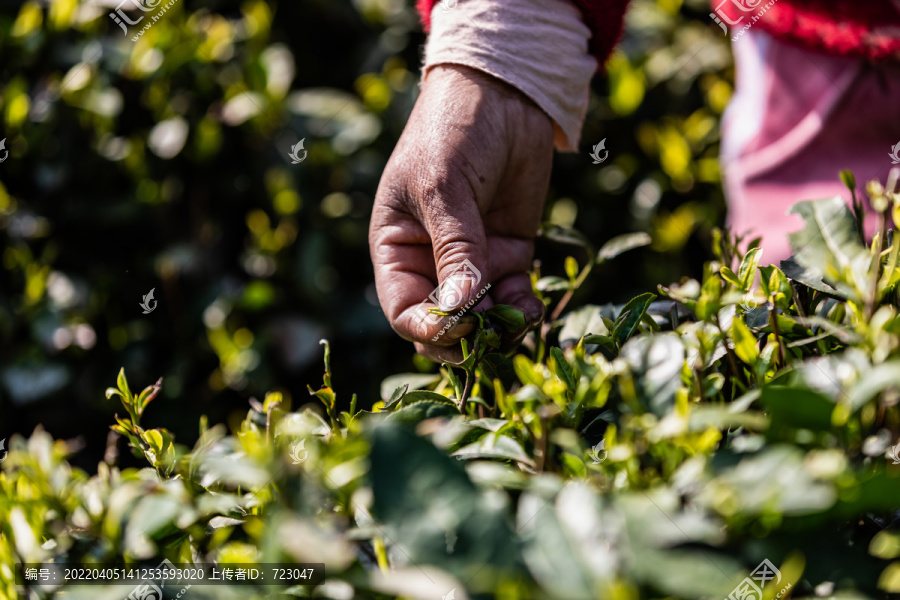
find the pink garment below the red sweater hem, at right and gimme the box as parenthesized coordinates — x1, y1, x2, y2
(721, 28, 900, 264)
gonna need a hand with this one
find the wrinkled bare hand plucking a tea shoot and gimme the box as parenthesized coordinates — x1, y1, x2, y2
(369, 65, 553, 363)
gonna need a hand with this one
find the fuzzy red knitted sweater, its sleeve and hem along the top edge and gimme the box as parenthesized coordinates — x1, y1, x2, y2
(416, 0, 900, 63)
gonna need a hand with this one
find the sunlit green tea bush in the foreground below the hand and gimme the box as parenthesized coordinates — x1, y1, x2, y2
(0, 171, 900, 600)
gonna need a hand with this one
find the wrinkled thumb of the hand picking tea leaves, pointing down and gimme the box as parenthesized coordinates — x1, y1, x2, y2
(428, 193, 490, 312)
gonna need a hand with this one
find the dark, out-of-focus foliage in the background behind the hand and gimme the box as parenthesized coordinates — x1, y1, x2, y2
(0, 0, 733, 466)
